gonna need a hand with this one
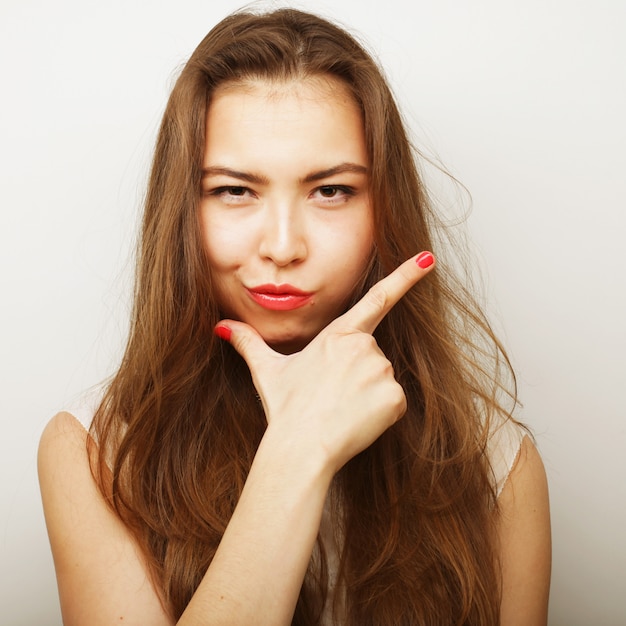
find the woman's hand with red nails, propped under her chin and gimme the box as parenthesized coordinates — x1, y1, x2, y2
(216, 252, 434, 472)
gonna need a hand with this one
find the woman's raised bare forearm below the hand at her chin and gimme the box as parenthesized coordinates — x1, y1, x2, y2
(179, 433, 332, 626)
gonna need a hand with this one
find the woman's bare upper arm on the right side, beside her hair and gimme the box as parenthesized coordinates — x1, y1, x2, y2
(498, 437, 552, 626)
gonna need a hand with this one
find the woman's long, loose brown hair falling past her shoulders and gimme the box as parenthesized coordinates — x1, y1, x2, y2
(92, 9, 515, 626)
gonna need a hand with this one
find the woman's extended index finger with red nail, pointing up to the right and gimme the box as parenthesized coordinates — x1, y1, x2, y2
(338, 252, 435, 333)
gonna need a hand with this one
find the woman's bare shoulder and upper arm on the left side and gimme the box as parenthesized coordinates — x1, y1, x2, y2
(38, 413, 172, 626)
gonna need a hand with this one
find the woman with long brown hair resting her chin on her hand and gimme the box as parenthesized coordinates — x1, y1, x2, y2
(39, 10, 550, 625)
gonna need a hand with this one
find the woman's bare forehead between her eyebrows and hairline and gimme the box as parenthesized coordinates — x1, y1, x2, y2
(204, 76, 367, 168)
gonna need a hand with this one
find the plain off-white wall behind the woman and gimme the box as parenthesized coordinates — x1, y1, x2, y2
(0, 0, 626, 626)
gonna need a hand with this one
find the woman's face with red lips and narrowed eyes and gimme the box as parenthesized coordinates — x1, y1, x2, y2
(200, 78, 373, 353)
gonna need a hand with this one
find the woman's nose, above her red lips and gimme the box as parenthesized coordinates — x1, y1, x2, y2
(259, 202, 307, 267)
